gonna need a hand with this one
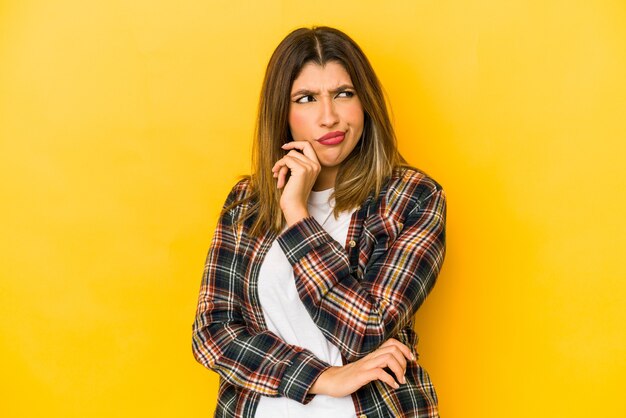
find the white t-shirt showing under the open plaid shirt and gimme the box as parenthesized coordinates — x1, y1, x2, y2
(256, 189, 356, 418)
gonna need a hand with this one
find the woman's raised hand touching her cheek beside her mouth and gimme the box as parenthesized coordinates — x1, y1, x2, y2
(272, 141, 321, 226)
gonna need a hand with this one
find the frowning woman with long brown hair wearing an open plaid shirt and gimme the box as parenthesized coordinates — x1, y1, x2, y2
(193, 27, 446, 418)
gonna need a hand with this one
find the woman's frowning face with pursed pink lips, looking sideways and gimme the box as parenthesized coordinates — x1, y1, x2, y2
(289, 61, 364, 178)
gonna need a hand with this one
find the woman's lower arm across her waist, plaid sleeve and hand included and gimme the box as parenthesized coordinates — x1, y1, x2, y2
(192, 183, 412, 404)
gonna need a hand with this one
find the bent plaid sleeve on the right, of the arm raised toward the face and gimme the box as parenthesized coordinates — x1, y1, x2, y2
(278, 188, 446, 362)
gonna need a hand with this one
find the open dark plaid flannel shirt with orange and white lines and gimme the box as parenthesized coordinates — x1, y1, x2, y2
(192, 169, 446, 418)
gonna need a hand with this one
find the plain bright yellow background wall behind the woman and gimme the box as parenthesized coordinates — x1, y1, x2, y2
(0, 0, 626, 418)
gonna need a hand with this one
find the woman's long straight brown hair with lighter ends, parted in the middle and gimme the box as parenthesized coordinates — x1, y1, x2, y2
(233, 26, 406, 235)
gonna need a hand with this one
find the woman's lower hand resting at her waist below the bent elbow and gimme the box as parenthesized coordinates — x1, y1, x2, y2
(309, 338, 415, 397)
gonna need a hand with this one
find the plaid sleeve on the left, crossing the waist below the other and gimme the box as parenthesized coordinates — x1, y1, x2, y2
(192, 183, 330, 404)
